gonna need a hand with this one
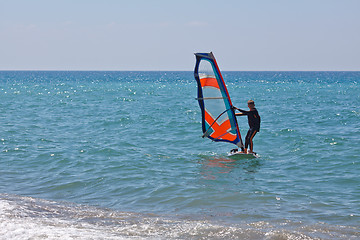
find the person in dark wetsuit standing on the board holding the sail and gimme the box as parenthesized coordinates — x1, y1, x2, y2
(235, 100, 261, 153)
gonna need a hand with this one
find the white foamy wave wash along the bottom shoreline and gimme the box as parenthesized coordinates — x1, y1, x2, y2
(0, 194, 360, 240)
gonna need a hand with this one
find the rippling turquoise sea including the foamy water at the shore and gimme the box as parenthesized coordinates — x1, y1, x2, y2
(0, 71, 360, 240)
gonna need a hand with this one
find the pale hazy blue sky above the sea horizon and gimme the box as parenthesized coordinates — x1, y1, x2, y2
(0, 0, 360, 71)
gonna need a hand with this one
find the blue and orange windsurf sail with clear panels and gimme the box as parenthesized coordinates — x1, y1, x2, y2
(194, 52, 243, 147)
